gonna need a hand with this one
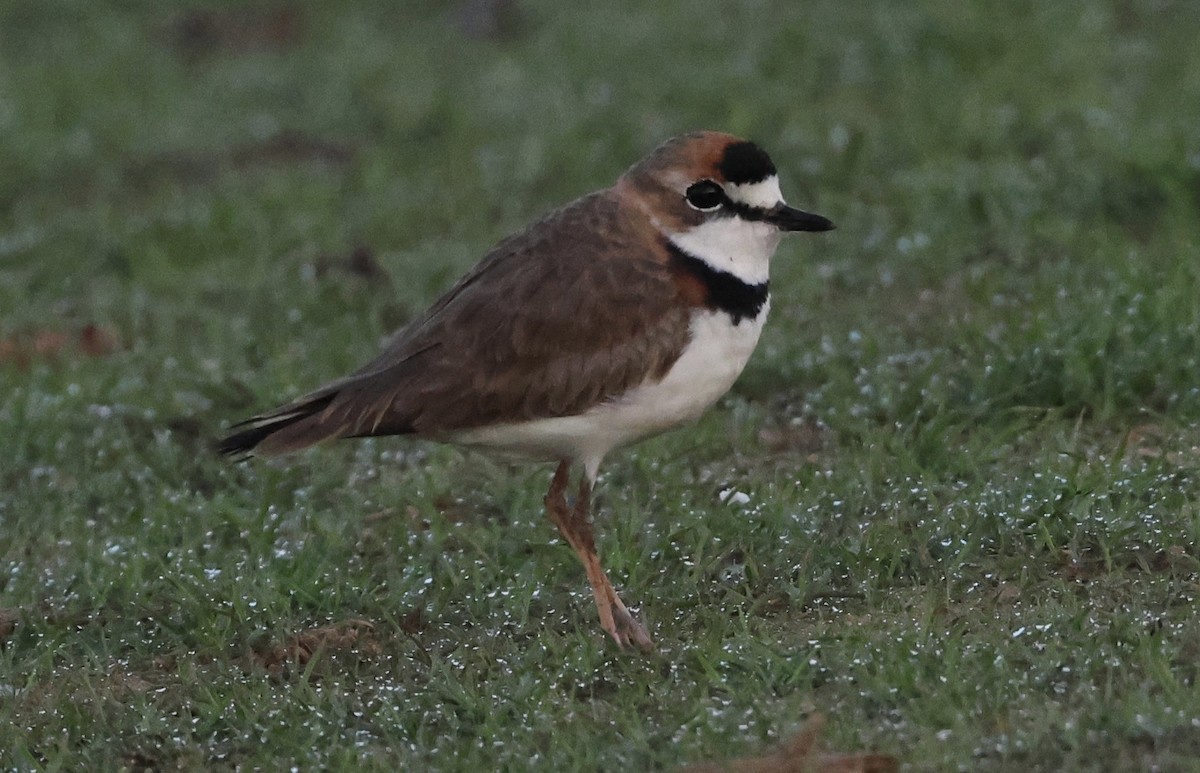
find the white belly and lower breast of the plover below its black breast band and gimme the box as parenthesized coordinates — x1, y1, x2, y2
(450, 300, 770, 479)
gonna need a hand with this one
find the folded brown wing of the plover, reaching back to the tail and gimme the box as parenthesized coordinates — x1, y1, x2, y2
(222, 192, 689, 453)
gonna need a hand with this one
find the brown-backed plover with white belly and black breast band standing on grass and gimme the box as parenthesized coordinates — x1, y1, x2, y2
(217, 131, 834, 652)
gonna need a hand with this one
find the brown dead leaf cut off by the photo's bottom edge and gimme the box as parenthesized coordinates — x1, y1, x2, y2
(680, 715, 900, 773)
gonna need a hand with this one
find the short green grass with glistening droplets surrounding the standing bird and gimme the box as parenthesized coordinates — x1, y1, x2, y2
(0, 0, 1200, 771)
